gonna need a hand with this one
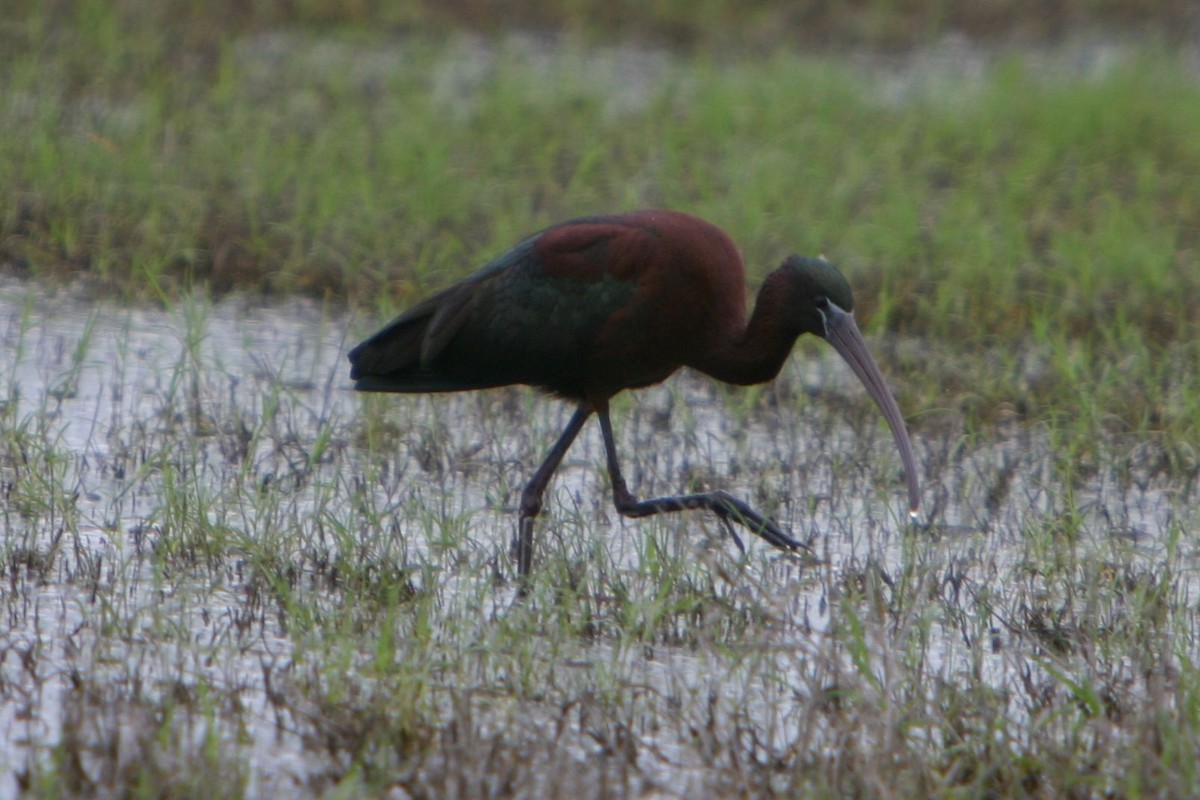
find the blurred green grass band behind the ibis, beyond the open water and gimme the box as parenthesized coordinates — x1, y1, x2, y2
(0, 0, 1200, 435)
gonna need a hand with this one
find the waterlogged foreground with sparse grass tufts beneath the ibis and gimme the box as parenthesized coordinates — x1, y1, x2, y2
(0, 287, 1200, 796)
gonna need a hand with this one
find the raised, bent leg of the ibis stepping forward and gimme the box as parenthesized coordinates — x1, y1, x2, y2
(596, 403, 809, 553)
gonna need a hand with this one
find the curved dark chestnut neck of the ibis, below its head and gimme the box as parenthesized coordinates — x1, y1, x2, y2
(690, 272, 800, 386)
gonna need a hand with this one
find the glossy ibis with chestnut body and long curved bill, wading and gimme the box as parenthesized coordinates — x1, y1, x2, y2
(349, 211, 919, 591)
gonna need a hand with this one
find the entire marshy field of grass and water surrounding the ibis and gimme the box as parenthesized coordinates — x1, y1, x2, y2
(0, 0, 1200, 798)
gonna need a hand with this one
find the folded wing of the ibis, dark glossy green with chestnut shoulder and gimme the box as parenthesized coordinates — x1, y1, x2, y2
(349, 215, 678, 397)
